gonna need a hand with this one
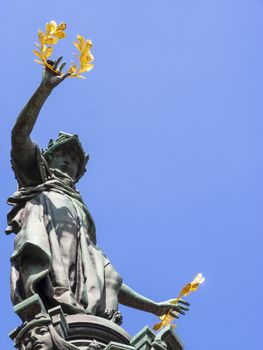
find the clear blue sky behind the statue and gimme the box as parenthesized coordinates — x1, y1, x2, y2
(0, 0, 263, 350)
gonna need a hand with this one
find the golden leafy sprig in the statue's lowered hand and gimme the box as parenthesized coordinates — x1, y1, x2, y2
(153, 273, 205, 331)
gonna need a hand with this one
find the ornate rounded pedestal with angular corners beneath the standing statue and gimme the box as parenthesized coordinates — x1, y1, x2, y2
(10, 295, 183, 350)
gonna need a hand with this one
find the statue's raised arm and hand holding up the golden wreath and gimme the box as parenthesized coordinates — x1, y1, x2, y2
(12, 57, 69, 161)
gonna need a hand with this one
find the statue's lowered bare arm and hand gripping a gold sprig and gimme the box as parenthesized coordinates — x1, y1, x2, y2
(118, 283, 189, 318)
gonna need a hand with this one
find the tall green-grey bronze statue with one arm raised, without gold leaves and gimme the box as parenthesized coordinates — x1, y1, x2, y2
(7, 58, 189, 324)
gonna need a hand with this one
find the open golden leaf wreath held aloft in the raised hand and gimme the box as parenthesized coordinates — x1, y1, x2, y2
(33, 20, 94, 79)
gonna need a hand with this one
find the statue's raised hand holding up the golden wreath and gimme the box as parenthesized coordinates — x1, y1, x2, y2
(41, 56, 70, 89)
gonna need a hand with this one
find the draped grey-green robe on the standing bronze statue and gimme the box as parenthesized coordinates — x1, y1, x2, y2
(6, 147, 110, 315)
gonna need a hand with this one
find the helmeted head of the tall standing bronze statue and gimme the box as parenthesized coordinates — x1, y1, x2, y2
(43, 132, 89, 182)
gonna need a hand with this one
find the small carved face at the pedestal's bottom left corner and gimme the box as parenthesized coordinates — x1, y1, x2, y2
(24, 326, 53, 350)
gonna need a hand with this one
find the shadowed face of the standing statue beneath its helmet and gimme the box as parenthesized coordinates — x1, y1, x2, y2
(49, 143, 80, 180)
